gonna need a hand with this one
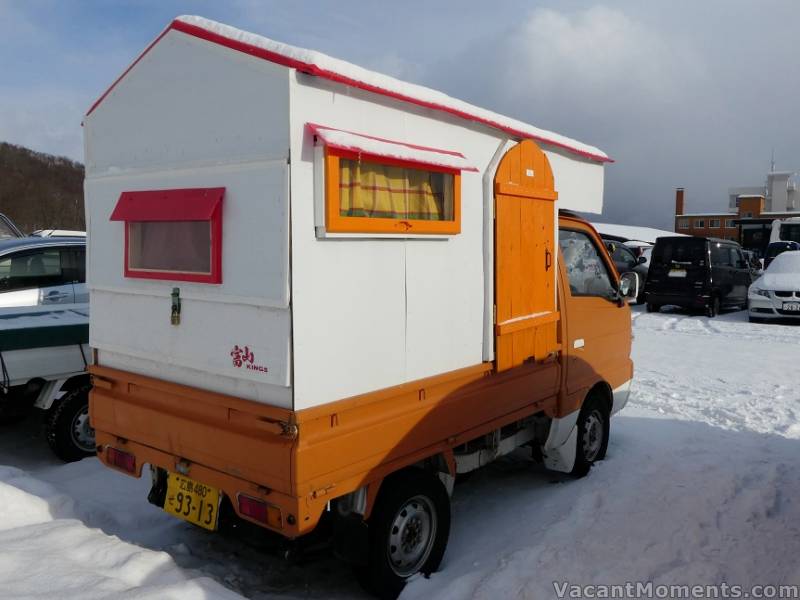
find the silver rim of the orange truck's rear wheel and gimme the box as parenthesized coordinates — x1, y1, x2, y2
(386, 496, 437, 577)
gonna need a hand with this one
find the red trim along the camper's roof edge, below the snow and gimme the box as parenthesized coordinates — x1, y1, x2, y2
(86, 19, 614, 162)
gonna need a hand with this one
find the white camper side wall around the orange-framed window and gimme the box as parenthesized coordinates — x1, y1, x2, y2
(291, 73, 503, 409)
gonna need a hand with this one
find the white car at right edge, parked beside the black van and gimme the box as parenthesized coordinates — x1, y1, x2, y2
(747, 250, 800, 322)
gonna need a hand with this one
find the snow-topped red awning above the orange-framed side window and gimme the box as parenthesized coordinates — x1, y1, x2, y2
(308, 123, 478, 171)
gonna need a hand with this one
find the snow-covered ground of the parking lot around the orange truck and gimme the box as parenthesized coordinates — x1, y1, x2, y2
(0, 308, 800, 600)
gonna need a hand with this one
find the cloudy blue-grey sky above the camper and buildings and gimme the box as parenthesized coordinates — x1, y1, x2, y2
(0, 0, 800, 228)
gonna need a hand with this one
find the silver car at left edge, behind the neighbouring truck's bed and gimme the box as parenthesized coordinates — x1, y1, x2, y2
(0, 237, 89, 309)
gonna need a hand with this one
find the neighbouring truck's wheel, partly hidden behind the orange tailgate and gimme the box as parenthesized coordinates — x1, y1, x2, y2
(45, 385, 95, 462)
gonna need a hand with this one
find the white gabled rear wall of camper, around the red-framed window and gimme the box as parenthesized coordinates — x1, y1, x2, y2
(85, 31, 291, 407)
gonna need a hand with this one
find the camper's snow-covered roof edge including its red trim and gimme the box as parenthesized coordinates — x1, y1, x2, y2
(86, 15, 613, 162)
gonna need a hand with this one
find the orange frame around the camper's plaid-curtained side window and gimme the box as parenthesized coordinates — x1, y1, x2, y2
(325, 146, 461, 235)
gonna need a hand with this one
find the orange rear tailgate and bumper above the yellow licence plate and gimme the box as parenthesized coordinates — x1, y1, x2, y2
(89, 365, 310, 538)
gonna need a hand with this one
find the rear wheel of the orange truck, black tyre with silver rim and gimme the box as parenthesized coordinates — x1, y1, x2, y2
(356, 469, 450, 599)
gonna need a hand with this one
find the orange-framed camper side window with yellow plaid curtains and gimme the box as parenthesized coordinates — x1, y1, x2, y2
(325, 149, 461, 234)
